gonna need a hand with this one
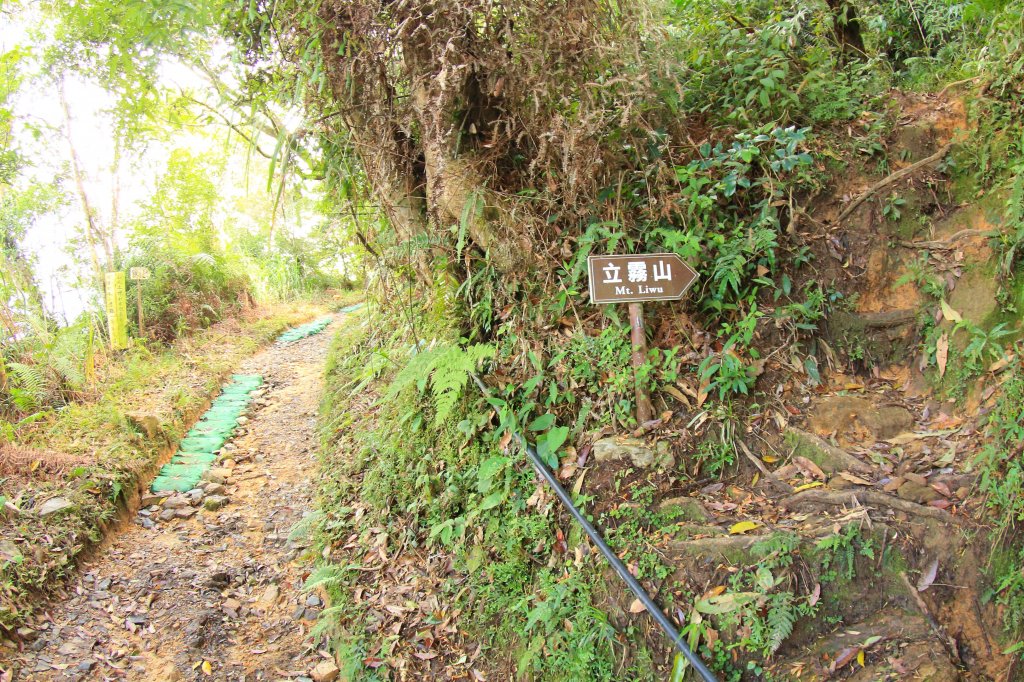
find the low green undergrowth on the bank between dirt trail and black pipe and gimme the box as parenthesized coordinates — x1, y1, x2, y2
(309, 313, 655, 680)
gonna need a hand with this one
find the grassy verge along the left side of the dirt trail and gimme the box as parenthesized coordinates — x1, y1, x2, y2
(0, 302, 322, 630)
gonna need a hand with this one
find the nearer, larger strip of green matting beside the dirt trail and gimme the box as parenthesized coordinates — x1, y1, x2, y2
(150, 374, 264, 493)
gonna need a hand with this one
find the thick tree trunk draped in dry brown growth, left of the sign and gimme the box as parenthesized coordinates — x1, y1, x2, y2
(319, 0, 636, 280)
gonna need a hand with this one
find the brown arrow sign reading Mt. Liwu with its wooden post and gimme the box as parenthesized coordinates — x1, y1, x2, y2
(587, 253, 697, 424)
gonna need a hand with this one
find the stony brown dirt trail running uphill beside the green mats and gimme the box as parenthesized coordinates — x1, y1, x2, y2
(4, 315, 338, 682)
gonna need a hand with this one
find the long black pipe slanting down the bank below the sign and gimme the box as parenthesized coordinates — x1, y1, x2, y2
(472, 374, 718, 682)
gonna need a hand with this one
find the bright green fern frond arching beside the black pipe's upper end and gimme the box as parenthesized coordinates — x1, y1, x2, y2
(387, 343, 495, 424)
